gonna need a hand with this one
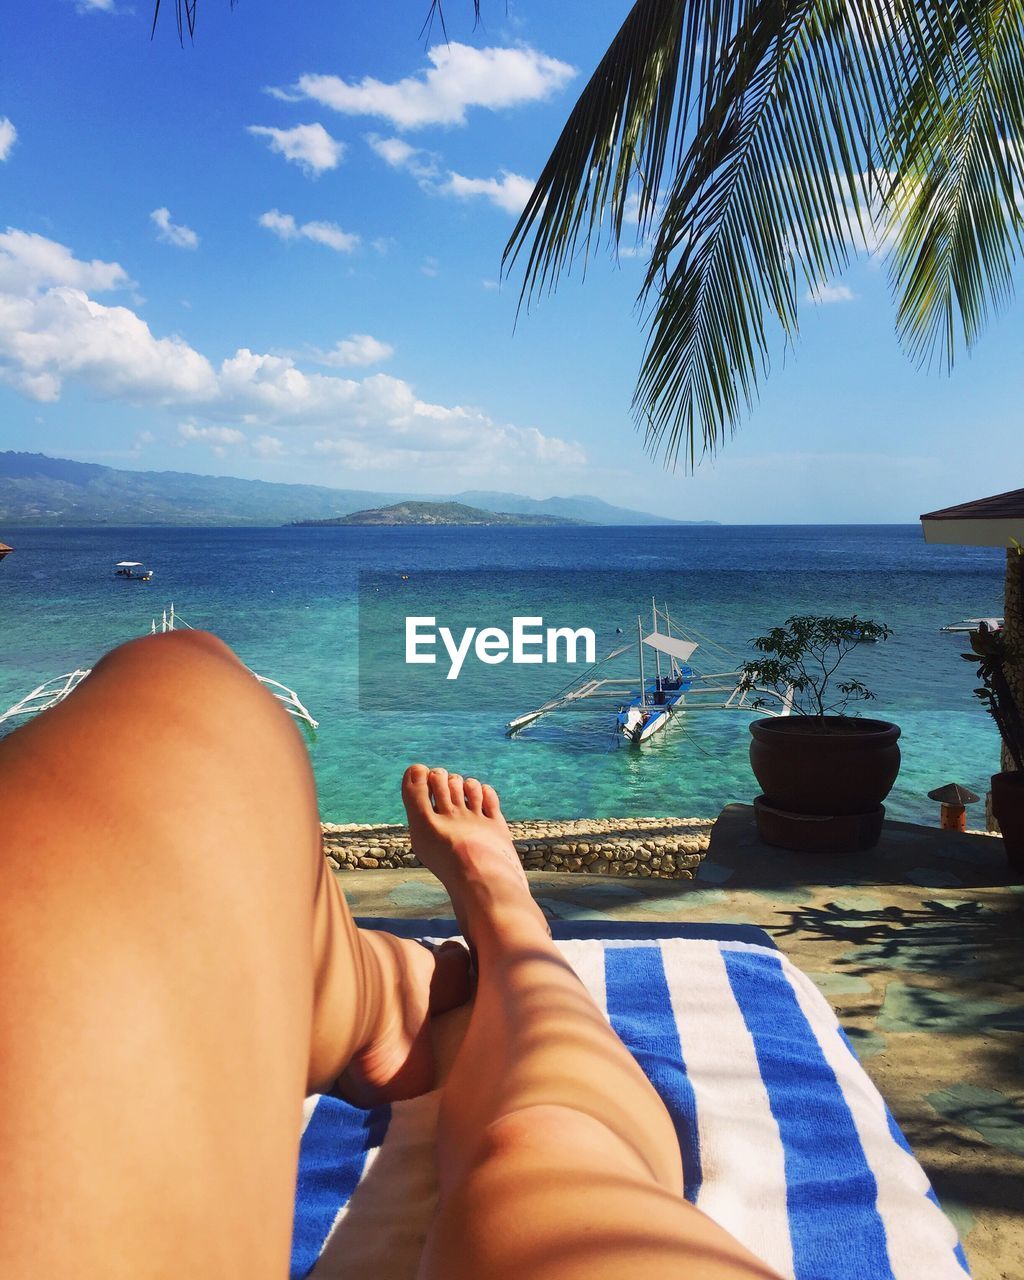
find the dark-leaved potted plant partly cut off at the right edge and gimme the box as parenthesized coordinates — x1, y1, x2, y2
(964, 625, 1024, 867)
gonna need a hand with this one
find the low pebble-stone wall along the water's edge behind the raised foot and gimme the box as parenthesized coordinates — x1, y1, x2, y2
(323, 818, 714, 879)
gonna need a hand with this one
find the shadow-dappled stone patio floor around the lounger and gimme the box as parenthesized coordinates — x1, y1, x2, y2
(339, 805, 1024, 1280)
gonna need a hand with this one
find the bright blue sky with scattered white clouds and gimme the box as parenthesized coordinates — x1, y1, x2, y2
(0, 0, 1024, 522)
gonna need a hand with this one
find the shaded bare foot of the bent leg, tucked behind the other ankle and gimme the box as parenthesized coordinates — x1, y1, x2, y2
(334, 929, 471, 1107)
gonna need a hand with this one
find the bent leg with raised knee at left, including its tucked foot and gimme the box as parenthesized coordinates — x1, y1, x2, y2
(0, 632, 466, 1280)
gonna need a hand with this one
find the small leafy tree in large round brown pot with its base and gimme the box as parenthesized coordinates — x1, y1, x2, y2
(741, 614, 900, 851)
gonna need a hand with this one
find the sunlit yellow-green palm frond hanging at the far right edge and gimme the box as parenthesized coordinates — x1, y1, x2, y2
(886, 0, 1024, 369)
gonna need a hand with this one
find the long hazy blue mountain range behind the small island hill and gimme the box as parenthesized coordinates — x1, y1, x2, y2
(0, 452, 706, 526)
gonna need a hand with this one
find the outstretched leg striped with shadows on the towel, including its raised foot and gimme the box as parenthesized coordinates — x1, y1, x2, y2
(403, 765, 774, 1280)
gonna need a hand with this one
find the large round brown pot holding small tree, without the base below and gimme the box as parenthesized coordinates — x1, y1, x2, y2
(750, 716, 900, 815)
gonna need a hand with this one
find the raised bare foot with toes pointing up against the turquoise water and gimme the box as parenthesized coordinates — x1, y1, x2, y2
(402, 764, 548, 940)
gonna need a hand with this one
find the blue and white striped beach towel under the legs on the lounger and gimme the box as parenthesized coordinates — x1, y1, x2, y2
(291, 938, 969, 1280)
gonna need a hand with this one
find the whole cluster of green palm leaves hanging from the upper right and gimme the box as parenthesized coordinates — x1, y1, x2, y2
(504, 0, 1024, 466)
